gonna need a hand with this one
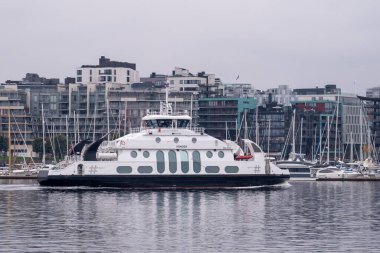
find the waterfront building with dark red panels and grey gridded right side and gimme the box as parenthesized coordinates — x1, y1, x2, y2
(292, 84, 367, 161)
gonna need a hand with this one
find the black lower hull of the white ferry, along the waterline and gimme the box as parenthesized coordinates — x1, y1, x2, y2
(38, 175, 289, 189)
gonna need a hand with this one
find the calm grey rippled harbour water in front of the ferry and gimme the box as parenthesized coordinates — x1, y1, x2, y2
(0, 180, 380, 252)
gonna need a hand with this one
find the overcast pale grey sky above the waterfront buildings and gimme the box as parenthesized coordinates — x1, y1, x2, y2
(0, 0, 380, 94)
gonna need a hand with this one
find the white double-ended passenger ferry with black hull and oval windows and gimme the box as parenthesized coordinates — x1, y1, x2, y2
(38, 95, 289, 189)
